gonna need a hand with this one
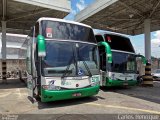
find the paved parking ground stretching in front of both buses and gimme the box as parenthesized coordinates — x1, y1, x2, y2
(0, 80, 160, 118)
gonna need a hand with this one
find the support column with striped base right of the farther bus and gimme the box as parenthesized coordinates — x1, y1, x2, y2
(143, 19, 153, 86)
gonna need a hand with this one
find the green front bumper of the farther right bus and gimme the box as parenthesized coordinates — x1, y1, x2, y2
(106, 79, 137, 86)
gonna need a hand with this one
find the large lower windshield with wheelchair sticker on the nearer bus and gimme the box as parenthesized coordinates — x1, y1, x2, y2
(42, 40, 99, 77)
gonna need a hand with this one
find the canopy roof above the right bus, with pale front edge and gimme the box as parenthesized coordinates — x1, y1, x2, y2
(75, 0, 160, 35)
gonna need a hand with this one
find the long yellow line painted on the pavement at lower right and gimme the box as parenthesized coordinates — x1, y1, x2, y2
(86, 102, 160, 114)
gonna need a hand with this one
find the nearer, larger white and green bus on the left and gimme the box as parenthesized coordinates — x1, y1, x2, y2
(23, 18, 110, 102)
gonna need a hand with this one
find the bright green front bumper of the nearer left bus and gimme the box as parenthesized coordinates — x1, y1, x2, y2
(41, 86, 99, 102)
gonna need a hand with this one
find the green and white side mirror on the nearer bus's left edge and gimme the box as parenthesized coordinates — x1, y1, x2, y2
(37, 35, 46, 57)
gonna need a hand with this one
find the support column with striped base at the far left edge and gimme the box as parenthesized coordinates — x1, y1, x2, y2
(1, 21, 7, 83)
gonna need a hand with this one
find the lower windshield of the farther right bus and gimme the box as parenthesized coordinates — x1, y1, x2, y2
(111, 51, 136, 73)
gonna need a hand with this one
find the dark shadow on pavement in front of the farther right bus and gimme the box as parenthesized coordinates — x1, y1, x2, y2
(101, 82, 160, 104)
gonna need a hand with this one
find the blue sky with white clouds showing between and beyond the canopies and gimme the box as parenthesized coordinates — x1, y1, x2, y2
(65, 0, 160, 58)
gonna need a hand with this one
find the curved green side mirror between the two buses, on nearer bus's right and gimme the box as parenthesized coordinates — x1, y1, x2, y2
(98, 42, 112, 63)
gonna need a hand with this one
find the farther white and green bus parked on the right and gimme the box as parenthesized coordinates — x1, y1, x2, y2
(95, 33, 146, 87)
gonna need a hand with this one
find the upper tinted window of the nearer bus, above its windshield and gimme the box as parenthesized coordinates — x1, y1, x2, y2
(41, 21, 96, 43)
